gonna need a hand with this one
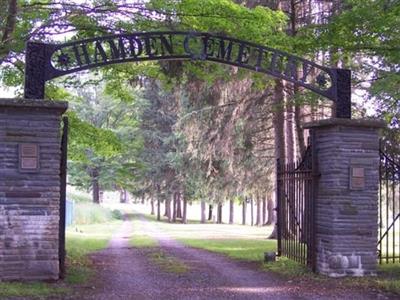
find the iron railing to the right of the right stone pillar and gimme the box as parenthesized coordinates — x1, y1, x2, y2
(378, 150, 400, 263)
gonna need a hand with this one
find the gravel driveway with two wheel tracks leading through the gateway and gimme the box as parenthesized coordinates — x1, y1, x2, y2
(74, 219, 396, 300)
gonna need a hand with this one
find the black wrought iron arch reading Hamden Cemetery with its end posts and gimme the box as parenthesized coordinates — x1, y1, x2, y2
(25, 31, 351, 118)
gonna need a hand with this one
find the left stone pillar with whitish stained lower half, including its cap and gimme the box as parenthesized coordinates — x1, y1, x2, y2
(0, 99, 67, 281)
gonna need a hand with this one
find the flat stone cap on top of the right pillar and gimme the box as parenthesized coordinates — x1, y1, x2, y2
(303, 118, 387, 129)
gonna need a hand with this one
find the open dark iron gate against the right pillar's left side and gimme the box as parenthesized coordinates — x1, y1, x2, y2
(277, 141, 316, 271)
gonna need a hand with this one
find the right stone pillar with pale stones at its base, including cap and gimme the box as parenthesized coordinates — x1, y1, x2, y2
(305, 119, 384, 277)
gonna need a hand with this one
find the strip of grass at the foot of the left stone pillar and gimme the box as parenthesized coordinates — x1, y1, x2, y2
(0, 282, 70, 299)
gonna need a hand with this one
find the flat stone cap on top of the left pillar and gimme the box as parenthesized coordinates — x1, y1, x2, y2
(0, 98, 68, 114)
